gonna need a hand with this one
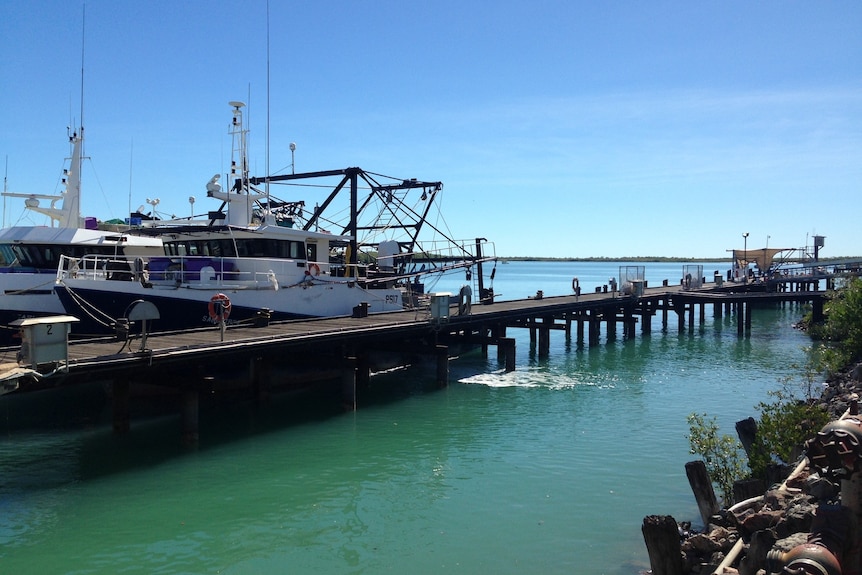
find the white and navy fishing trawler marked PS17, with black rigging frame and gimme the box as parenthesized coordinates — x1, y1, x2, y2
(54, 102, 495, 333)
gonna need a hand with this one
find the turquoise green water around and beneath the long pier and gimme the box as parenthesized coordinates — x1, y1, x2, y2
(0, 263, 808, 575)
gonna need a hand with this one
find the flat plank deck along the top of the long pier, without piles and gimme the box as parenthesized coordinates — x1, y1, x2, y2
(6, 286, 825, 383)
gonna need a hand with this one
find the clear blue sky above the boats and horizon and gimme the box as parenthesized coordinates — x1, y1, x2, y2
(0, 0, 862, 257)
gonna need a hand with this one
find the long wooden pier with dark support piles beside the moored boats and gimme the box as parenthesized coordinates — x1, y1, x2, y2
(4, 284, 826, 442)
